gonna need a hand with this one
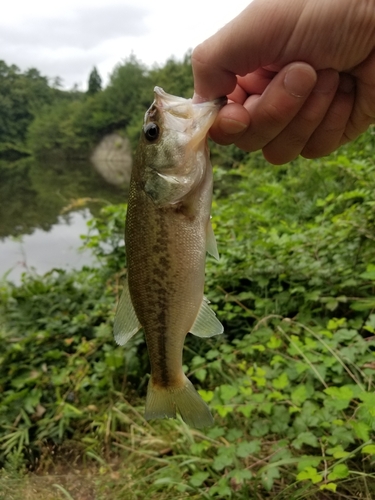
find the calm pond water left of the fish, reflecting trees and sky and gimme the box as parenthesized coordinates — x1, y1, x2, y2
(0, 158, 127, 284)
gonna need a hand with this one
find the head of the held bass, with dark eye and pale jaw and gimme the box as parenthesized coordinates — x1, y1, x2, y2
(134, 87, 226, 206)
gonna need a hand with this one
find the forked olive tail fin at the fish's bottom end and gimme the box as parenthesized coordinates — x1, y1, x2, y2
(145, 375, 214, 428)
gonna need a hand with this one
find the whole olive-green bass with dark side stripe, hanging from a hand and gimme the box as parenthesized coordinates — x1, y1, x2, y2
(114, 87, 226, 428)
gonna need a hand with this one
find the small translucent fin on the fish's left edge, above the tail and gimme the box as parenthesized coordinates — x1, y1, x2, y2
(113, 280, 141, 345)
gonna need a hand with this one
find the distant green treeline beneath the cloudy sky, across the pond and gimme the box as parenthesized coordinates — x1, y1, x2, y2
(0, 54, 193, 158)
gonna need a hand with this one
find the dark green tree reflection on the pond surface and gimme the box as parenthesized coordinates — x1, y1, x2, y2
(0, 159, 127, 239)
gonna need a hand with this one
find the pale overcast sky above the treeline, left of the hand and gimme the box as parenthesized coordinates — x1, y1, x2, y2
(0, 0, 250, 90)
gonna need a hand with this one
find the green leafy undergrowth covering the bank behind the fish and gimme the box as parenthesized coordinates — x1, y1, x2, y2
(0, 127, 375, 500)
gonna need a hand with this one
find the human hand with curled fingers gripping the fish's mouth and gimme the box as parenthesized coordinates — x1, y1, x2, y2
(192, 0, 375, 164)
